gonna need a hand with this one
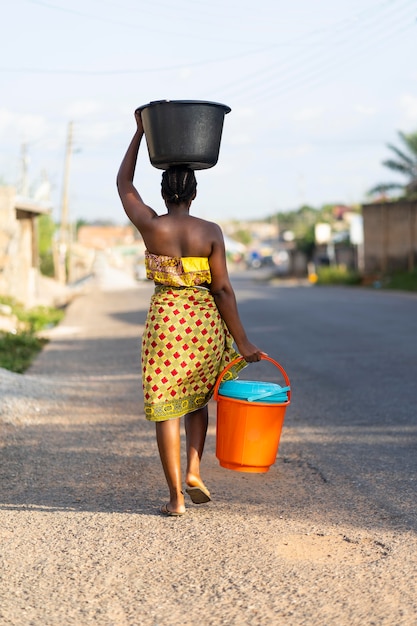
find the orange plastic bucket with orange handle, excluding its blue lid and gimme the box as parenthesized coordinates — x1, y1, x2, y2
(214, 355, 291, 473)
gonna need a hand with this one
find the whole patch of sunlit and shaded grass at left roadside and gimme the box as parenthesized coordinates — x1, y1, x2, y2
(0, 296, 64, 374)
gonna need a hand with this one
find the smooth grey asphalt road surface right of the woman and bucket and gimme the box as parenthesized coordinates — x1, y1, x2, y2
(234, 275, 417, 530)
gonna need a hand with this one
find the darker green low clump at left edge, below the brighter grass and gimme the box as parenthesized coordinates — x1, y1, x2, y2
(0, 332, 47, 374)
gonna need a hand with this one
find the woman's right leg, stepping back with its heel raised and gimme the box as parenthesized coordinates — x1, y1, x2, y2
(184, 406, 208, 487)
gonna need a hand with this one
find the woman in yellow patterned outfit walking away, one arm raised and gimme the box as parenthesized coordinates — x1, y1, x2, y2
(117, 111, 262, 516)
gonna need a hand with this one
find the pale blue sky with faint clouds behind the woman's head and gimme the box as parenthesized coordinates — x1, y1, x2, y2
(0, 0, 417, 223)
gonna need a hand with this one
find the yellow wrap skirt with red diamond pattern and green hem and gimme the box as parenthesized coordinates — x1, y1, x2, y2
(142, 286, 246, 422)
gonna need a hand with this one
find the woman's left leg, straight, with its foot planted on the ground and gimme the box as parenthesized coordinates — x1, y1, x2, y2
(156, 419, 185, 513)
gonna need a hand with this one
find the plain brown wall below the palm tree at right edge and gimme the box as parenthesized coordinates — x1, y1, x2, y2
(362, 200, 417, 275)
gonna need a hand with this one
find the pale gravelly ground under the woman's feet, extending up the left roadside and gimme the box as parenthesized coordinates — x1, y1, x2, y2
(0, 274, 417, 626)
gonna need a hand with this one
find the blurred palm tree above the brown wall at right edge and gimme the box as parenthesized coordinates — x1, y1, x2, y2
(369, 131, 417, 196)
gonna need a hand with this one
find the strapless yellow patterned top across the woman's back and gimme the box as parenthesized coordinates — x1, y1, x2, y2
(145, 250, 211, 287)
